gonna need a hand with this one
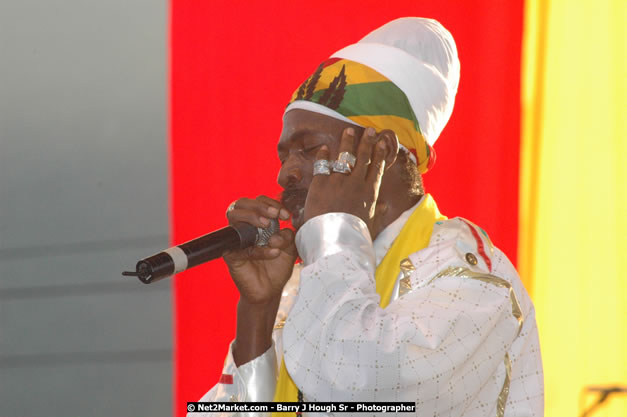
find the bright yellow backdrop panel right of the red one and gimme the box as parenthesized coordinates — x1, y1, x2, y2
(518, 0, 627, 417)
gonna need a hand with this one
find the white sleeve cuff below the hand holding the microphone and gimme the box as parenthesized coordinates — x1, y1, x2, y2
(188, 343, 277, 417)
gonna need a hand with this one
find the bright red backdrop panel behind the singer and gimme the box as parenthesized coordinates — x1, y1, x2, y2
(170, 0, 523, 416)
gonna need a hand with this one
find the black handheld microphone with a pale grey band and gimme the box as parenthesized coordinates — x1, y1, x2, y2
(122, 219, 279, 284)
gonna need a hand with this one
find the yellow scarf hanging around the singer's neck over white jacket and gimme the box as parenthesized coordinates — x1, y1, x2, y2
(272, 194, 446, 417)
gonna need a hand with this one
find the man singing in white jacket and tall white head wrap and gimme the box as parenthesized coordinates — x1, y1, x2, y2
(193, 18, 544, 416)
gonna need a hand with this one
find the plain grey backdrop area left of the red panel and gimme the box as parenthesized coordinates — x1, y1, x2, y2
(0, 0, 173, 417)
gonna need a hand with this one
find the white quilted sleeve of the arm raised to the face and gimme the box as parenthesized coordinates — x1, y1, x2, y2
(283, 213, 520, 416)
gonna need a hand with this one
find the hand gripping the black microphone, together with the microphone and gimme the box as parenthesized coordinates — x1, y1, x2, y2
(122, 196, 296, 303)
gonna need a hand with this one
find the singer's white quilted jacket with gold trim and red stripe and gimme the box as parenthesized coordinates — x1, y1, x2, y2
(189, 201, 544, 417)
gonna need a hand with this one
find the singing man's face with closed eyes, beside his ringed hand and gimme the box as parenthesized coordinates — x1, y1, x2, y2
(278, 110, 362, 229)
